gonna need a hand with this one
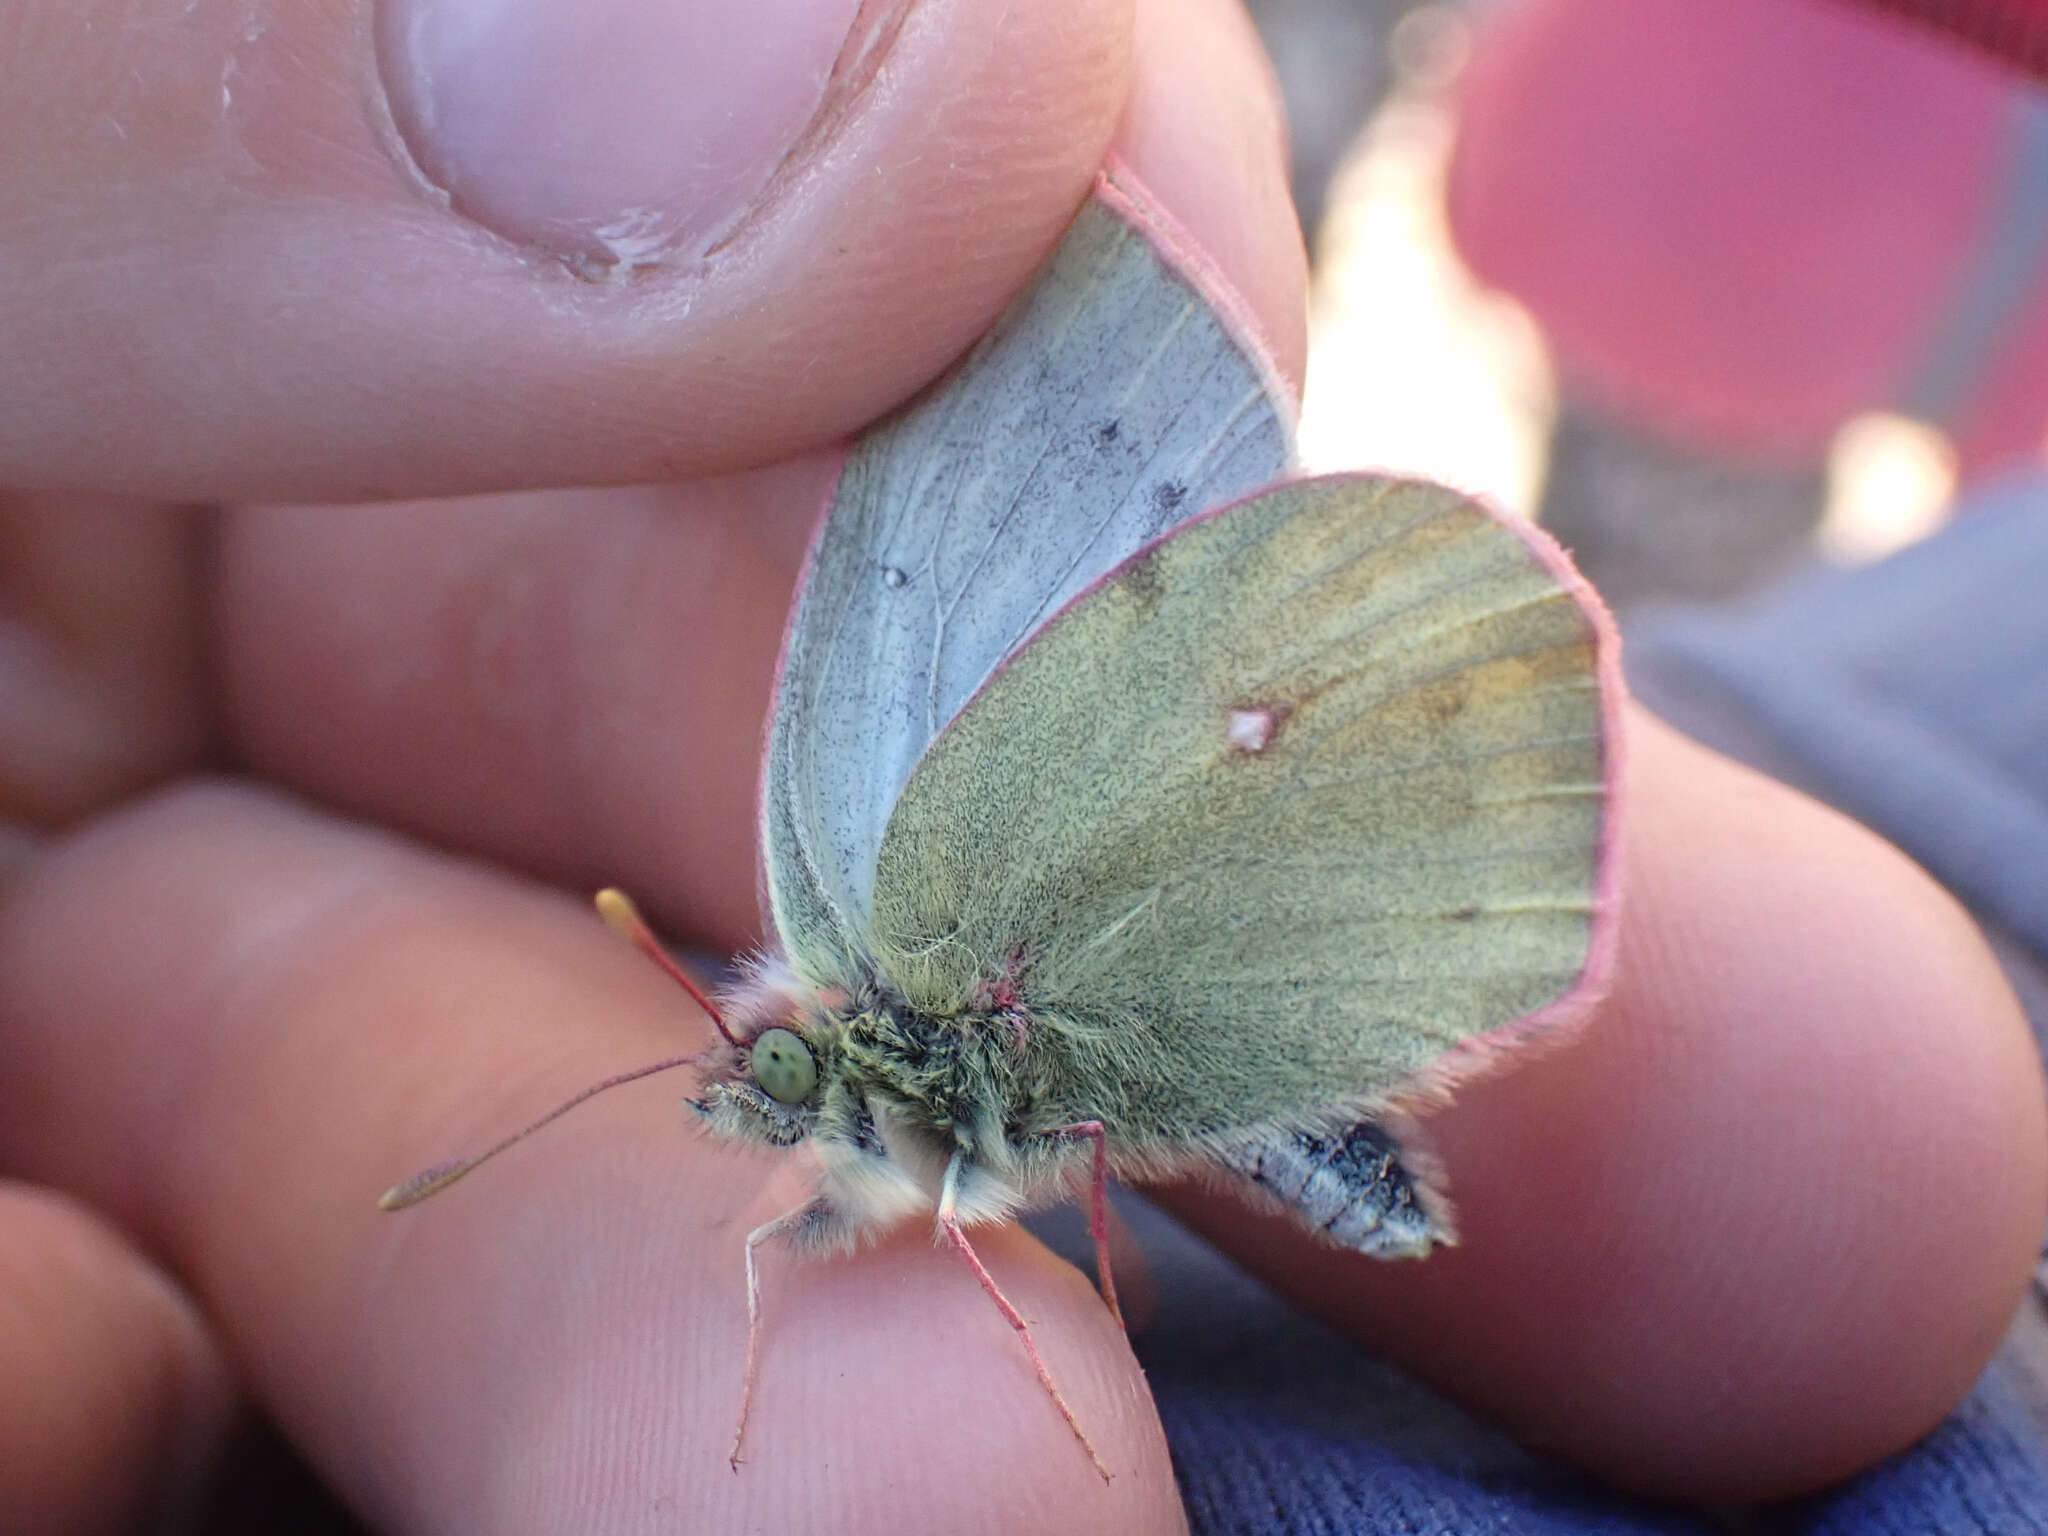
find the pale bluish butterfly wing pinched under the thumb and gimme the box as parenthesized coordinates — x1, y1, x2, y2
(762, 178, 1290, 981)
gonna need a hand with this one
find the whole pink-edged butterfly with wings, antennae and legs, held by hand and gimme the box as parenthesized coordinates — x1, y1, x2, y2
(383, 168, 1622, 1477)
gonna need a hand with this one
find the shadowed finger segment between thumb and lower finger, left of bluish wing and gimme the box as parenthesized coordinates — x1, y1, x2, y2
(219, 487, 806, 950)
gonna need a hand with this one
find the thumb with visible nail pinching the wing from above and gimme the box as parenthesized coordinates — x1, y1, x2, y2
(0, 0, 1130, 500)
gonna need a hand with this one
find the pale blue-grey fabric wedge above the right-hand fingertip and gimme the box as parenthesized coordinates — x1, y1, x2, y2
(1628, 477, 2048, 954)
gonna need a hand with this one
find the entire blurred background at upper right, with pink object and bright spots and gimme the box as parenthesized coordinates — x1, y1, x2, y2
(1249, 0, 2048, 616)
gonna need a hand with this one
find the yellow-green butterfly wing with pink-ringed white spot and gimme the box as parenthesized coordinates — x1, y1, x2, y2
(866, 475, 1614, 1155)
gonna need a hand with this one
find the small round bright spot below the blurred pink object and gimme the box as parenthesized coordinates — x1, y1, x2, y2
(1817, 412, 1956, 565)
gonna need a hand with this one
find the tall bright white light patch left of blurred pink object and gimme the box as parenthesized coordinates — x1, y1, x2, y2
(1300, 6, 1556, 516)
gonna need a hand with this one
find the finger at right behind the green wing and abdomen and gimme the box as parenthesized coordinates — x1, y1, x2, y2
(1174, 715, 2048, 1499)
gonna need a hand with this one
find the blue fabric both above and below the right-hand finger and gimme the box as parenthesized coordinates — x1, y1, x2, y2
(1097, 479, 2048, 1536)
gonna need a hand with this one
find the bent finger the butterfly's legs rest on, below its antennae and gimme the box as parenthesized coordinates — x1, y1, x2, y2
(0, 788, 1180, 1536)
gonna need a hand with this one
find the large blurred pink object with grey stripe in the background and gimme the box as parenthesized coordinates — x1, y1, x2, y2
(1450, 0, 2048, 473)
